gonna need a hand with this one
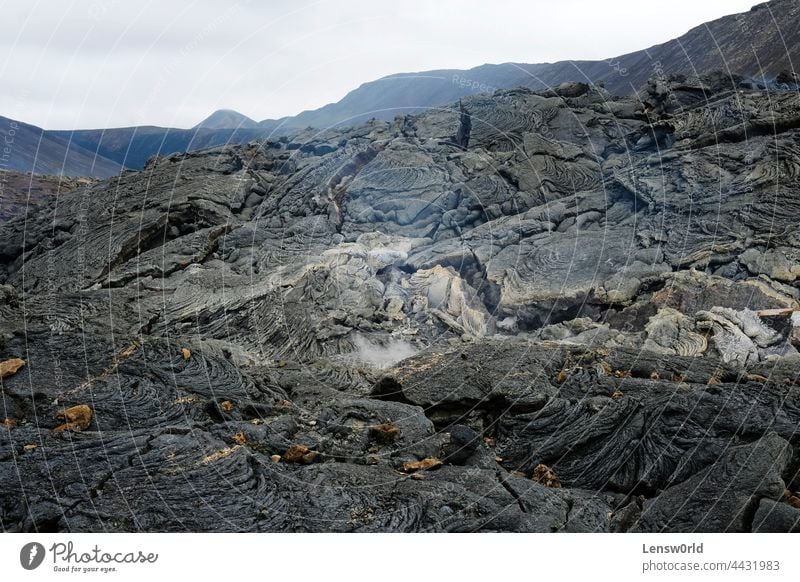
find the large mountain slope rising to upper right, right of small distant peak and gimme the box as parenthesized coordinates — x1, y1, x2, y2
(272, 0, 800, 127)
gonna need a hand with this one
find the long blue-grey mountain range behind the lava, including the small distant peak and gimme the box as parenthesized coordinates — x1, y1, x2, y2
(3, 0, 800, 177)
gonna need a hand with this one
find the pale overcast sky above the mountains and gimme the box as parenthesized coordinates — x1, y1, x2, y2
(0, 0, 757, 129)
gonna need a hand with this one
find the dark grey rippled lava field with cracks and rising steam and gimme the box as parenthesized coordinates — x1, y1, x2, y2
(0, 75, 800, 532)
